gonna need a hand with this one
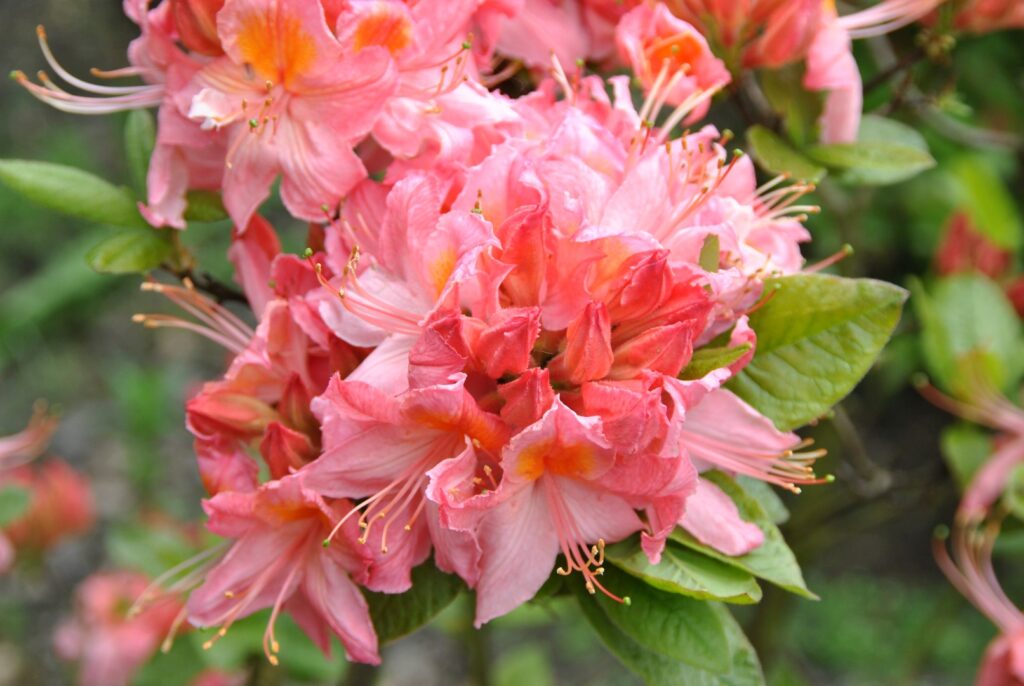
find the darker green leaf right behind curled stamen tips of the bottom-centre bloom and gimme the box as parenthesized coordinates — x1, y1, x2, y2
(591, 566, 729, 674)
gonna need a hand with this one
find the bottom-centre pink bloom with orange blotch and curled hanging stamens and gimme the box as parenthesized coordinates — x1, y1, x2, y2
(440, 399, 650, 626)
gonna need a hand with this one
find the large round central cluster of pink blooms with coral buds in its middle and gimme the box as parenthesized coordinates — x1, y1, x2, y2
(298, 71, 818, 624)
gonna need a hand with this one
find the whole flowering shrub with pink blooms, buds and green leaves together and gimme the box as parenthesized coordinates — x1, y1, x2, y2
(0, 0, 1024, 684)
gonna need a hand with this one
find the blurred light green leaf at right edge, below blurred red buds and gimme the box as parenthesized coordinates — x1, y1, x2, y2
(911, 273, 1024, 392)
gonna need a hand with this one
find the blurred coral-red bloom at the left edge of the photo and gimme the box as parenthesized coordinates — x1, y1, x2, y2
(0, 458, 95, 565)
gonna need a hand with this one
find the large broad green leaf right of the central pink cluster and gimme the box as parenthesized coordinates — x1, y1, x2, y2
(728, 273, 906, 430)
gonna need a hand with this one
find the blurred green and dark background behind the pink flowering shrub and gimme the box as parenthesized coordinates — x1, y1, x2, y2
(0, 0, 1024, 686)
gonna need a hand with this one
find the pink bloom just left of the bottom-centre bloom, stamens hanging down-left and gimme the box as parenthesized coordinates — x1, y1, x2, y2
(302, 377, 506, 593)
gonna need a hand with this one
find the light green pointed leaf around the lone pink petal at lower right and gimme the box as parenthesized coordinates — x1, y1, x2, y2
(670, 472, 817, 600)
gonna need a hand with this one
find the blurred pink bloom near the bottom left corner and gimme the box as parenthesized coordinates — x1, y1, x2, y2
(53, 571, 181, 686)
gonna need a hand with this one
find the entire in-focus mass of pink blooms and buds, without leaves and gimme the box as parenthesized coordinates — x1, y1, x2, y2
(18, 0, 935, 675)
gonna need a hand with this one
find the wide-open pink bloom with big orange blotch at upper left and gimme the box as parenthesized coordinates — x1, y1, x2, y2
(188, 0, 395, 226)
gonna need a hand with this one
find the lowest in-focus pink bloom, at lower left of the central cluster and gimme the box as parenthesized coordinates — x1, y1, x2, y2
(187, 475, 380, 664)
